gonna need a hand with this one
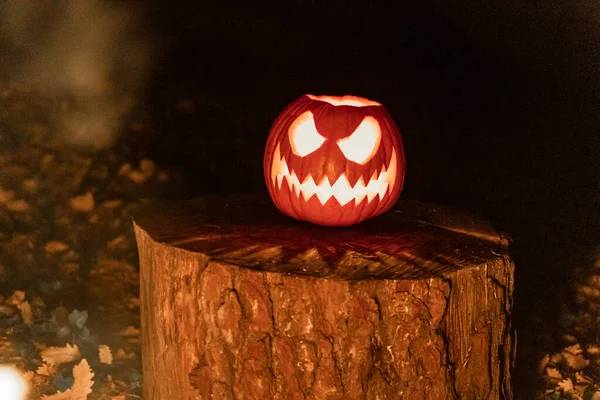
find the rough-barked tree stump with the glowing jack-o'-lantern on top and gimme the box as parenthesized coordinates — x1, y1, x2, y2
(134, 195, 514, 400)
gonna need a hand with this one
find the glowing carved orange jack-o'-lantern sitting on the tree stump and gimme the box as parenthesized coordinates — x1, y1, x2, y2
(263, 95, 406, 226)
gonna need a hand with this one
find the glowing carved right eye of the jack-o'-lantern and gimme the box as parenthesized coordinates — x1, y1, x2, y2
(337, 117, 381, 164)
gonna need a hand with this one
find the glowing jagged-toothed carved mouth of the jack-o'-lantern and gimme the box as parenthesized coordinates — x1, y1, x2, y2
(271, 145, 398, 206)
